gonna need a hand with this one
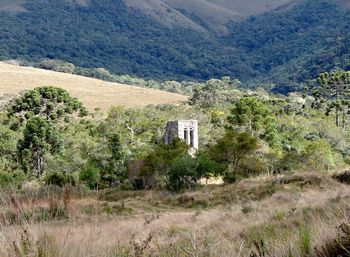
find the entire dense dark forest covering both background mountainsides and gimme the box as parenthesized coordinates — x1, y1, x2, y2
(0, 0, 350, 92)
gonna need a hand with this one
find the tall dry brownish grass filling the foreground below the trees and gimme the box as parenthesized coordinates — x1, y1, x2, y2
(0, 173, 350, 257)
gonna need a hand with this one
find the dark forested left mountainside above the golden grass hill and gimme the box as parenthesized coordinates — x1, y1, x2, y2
(0, 0, 226, 79)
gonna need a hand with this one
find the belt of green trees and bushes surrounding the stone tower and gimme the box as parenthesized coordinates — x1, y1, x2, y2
(0, 77, 350, 188)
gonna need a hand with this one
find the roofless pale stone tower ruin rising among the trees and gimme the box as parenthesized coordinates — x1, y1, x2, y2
(165, 120, 198, 152)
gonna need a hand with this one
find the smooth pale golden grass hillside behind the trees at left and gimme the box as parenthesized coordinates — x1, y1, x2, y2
(0, 62, 187, 111)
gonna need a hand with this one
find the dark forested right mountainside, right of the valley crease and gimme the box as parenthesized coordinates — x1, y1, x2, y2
(224, 0, 350, 93)
